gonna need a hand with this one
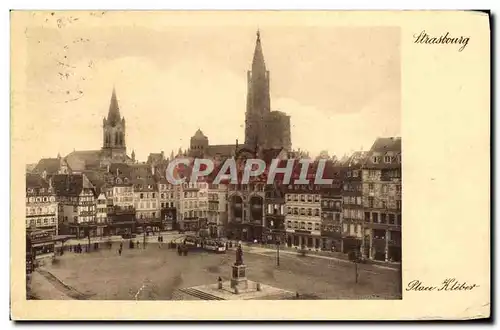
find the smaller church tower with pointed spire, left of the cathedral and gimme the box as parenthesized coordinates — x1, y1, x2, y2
(102, 88, 127, 161)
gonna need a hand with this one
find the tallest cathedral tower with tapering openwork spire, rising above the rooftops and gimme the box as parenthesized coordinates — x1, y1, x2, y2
(245, 31, 271, 148)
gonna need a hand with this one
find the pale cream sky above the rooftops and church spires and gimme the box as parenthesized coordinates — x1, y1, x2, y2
(19, 12, 401, 163)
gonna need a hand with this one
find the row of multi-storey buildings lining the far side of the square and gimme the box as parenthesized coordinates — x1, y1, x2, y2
(26, 138, 401, 260)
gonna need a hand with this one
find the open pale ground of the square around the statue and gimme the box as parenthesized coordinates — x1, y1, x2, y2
(38, 243, 401, 300)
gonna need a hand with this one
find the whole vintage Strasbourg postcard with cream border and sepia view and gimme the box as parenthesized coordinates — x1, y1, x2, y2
(10, 11, 491, 320)
